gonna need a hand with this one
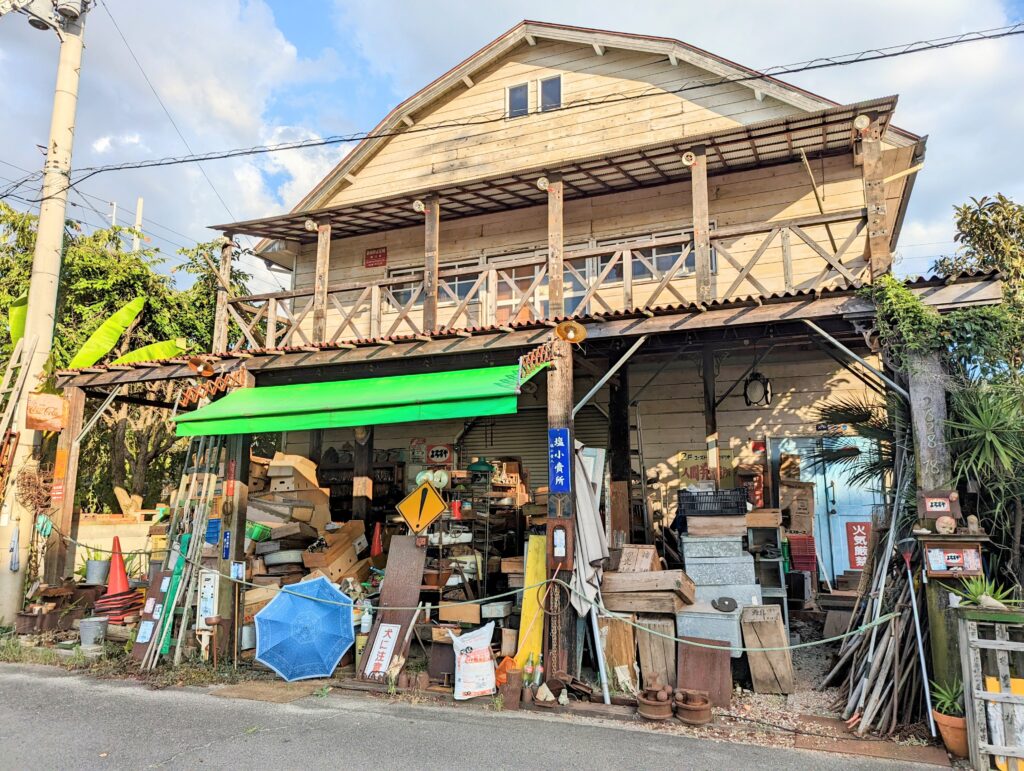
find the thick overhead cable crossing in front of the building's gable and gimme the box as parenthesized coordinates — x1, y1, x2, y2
(0, 21, 1024, 205)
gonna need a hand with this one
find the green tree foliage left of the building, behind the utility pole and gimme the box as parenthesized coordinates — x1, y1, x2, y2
(0, 202, 249, 510)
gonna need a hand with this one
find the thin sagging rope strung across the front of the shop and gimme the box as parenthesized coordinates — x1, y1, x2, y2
(48, 528, 899, 653)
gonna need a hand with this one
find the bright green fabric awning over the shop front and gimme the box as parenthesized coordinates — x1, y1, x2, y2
(176, 365, 543, 436)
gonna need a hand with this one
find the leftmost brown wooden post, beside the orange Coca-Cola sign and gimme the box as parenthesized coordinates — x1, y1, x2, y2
(43, 386, 85, 585)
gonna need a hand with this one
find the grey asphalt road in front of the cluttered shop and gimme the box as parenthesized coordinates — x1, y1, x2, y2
(0, 665, 934, 771)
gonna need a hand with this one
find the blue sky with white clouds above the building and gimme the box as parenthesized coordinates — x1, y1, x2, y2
(0, 0, 1024, 292)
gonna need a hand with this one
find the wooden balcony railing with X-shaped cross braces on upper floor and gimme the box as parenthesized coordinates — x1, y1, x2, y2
(227, 204, 869, 349)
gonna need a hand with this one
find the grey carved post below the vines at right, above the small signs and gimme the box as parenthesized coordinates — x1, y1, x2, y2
(907, 352, 952, 489)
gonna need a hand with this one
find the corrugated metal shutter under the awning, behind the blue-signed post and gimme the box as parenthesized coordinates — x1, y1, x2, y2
(462, 406, 608, 487)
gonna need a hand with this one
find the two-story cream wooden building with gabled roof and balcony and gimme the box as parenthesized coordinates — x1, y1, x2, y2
(56, 22, 997, 573)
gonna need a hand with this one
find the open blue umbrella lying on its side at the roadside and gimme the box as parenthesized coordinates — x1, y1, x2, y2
(256, 575, 355, 682)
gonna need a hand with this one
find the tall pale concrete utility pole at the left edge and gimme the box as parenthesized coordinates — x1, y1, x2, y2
(0, 0, 87, 624)
